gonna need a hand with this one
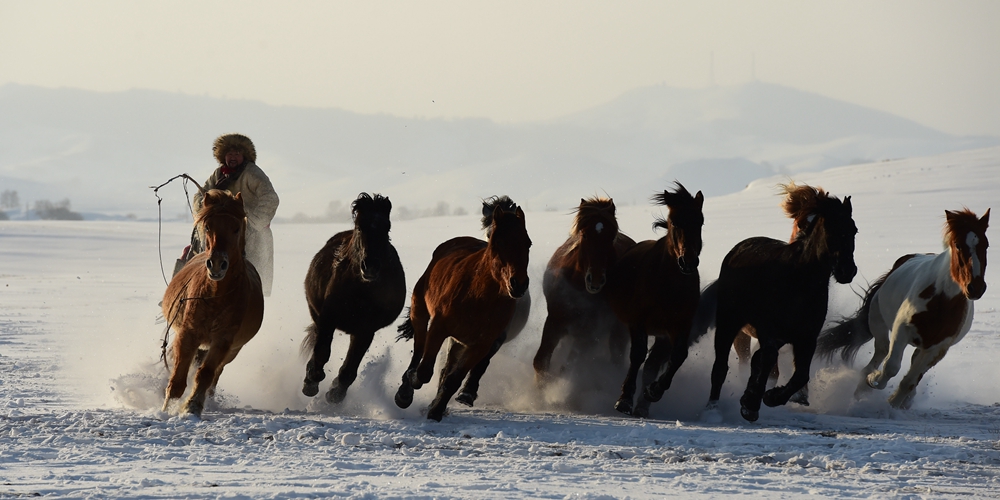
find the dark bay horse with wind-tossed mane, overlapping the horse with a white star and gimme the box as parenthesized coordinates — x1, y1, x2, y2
(607, 182, 705, 417)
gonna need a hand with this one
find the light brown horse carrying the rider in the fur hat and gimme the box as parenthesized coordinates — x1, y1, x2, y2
(162, 189, 264, 416)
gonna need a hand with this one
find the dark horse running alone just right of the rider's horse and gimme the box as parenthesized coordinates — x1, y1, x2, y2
(302, 193, 406, 403)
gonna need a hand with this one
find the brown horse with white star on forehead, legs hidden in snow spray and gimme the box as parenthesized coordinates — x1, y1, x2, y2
(533, 198, 635, 383)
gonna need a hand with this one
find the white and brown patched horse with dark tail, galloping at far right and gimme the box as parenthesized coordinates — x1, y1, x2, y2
(817, 209, 990, 408)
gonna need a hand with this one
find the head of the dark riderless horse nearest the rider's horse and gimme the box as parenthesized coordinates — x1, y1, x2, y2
(349, 193, 392, 282)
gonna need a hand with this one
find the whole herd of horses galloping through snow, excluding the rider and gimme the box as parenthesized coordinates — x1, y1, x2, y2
(162, 183, 989, 422)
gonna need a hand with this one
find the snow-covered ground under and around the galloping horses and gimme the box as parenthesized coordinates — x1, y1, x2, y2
(0, 148, 1000, 499)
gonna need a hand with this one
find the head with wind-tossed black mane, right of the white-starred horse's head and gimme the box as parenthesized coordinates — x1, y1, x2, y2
(652, 181, 705, 274)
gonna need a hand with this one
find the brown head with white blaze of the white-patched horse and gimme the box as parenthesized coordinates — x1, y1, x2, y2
(944, 209, 990, 300)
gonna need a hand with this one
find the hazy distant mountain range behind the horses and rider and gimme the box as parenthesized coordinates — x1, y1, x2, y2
(0, 83, 1000, 219)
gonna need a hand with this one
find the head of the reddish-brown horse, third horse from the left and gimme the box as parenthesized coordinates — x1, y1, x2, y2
(483, 196, 531, 299)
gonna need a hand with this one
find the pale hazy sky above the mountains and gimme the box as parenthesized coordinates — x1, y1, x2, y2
(0, 0, 1000, 135)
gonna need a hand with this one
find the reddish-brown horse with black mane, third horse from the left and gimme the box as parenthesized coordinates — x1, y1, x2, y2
(395, 196, 531, 421)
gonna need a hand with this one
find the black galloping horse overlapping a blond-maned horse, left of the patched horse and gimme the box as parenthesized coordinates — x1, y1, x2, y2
(691, 184, 858, 422)
